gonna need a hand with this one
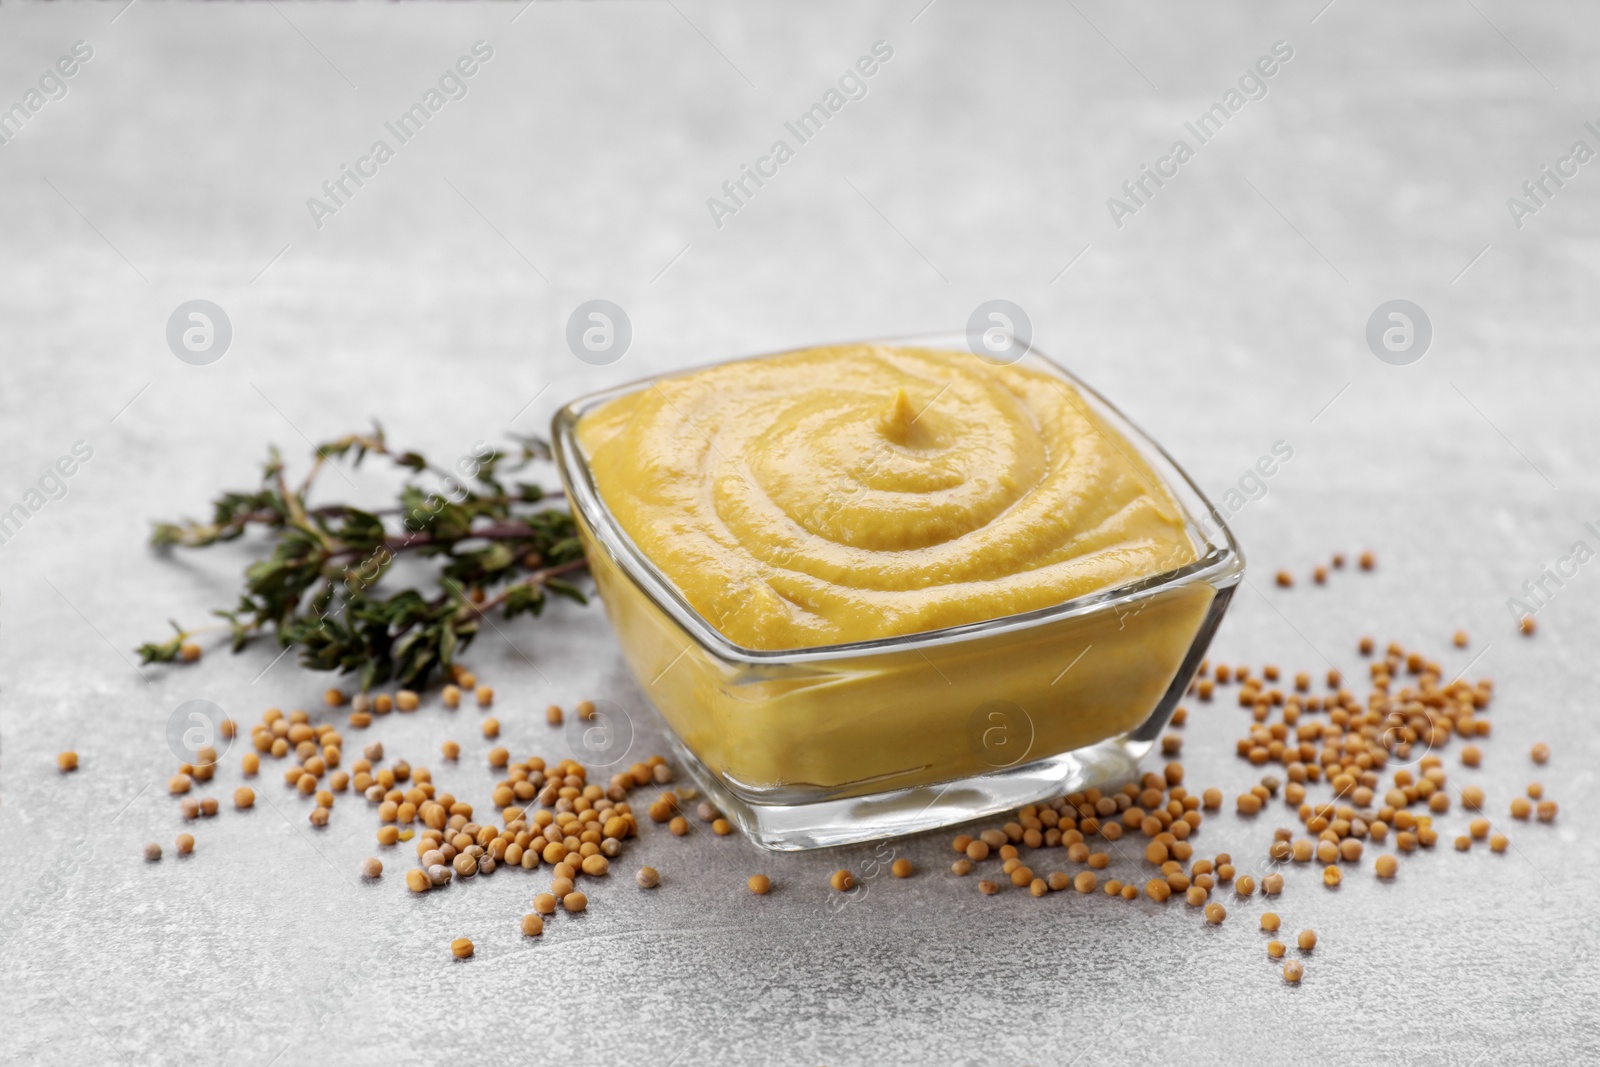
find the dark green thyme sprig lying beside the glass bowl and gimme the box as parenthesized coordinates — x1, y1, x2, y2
(138, 424, 587, 689)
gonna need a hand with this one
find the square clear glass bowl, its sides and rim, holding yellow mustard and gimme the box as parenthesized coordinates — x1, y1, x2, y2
(552, 334, 1245, 851)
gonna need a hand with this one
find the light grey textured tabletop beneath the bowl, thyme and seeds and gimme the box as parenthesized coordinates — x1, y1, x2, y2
(0, 0, 1600, 1065)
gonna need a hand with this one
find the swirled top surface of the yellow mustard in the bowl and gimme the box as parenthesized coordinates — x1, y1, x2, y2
(578, 344, 1195, 649)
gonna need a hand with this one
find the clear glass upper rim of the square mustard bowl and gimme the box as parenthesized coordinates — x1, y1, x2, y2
(550, 333, 1245, 665)
